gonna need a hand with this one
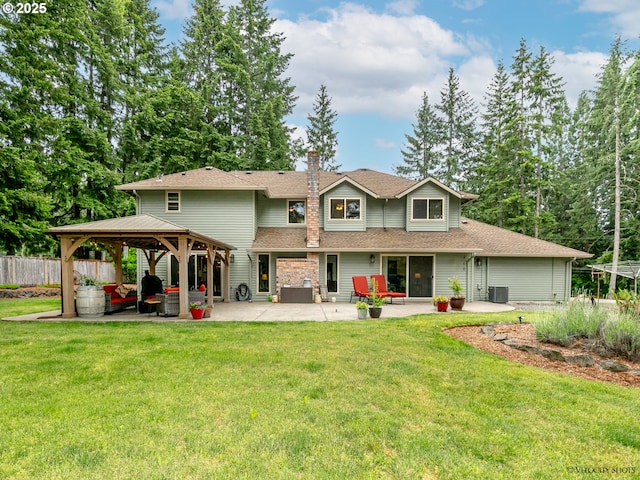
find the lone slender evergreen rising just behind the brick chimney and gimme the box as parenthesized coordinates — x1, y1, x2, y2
(307, 85, 342, 172)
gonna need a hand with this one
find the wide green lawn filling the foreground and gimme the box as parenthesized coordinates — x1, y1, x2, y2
(0, 306, 640, 480)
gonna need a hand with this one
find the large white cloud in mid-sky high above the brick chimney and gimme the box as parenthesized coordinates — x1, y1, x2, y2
(274, 3, 486, 118)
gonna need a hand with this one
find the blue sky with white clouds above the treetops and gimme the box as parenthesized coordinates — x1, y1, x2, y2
(152, 0, 640, 173)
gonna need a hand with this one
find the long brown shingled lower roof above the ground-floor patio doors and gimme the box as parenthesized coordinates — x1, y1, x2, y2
(250, 219, 591, 258)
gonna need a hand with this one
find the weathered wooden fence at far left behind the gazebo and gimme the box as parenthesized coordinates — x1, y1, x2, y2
(0, 255, 116, 287)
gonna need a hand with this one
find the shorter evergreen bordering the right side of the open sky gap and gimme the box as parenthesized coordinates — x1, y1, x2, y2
(394, 92, 444, 180)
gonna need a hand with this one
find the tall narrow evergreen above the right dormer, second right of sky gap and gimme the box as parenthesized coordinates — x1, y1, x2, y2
(436, 68, 477, 189)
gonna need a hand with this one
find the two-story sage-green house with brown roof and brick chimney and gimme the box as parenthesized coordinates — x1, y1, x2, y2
(118, 152, 590, 301)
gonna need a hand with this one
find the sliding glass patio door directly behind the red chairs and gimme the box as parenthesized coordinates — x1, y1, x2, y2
(382, 255, 433, 298)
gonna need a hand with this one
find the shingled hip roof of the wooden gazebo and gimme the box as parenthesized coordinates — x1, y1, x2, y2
(49, 214, 236, 250)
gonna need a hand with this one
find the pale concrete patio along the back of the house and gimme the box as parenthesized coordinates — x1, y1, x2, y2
(3, 301, 515, 322)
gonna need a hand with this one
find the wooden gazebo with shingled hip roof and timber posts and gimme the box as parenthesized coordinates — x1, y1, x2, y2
(48, 214, 236, 318)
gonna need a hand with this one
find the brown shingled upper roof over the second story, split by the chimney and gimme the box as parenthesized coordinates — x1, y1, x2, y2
(117, 167, 477, 200)
